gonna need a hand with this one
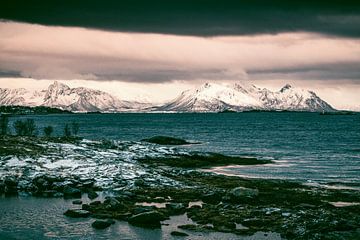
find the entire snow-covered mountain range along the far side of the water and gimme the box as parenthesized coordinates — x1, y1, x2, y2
(0, 81, 335, 112)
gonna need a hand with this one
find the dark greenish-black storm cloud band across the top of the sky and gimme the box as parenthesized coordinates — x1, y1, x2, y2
(0, 0, 360, 37)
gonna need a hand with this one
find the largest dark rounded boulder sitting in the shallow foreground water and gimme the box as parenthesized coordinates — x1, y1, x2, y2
(128, 211, 165, 228)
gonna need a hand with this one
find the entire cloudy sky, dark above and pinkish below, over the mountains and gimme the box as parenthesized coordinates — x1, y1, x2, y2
(0, 0, 360, 110)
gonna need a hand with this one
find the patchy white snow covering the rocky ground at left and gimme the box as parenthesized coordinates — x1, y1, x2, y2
(0, 140, 190, 188)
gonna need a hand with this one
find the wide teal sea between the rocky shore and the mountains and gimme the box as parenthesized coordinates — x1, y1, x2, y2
(8, 113, 360, 184)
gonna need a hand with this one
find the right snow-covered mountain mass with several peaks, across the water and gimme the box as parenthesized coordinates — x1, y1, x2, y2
(155, 83, 335, 112)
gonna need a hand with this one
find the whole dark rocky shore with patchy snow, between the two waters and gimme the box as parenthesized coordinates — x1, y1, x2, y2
(0, 136, 360, 239)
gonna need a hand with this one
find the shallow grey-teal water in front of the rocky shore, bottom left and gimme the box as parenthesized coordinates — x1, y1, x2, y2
(0, 197, 280, 240)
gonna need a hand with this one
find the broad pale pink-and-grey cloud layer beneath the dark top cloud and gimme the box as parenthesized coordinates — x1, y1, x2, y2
(0, 21, 360, 83)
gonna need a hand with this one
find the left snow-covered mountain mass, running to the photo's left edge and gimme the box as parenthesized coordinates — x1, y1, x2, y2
(0, 81, 149, 112)
